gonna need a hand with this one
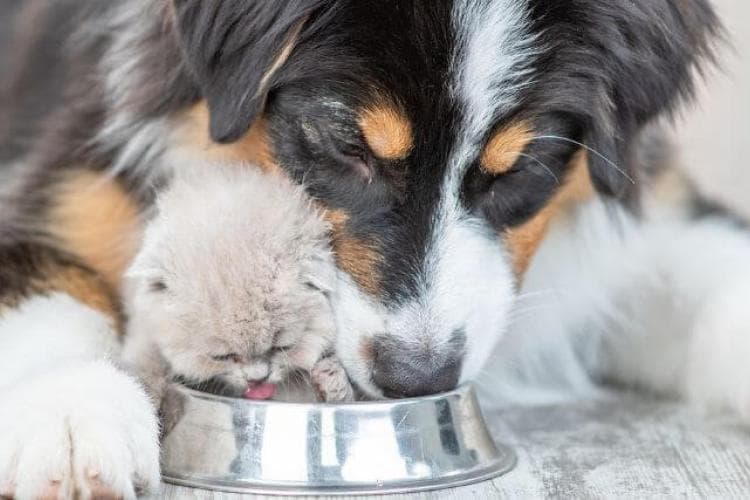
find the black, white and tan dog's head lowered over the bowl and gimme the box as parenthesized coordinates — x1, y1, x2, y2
(173, 0, 718, 396)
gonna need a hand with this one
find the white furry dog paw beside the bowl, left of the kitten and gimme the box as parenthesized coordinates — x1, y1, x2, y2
(0, 361, 159, 500)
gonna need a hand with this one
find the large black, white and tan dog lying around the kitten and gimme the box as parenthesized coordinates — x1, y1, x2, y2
(0, 0, 736, 498)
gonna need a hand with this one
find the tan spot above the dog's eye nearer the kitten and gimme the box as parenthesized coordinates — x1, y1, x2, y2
(359, 104, 414, 160)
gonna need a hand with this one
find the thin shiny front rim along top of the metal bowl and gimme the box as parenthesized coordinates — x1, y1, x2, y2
(176, 382, 476, 409)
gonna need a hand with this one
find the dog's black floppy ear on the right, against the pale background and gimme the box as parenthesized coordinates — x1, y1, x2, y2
(574, 0, 721, 199)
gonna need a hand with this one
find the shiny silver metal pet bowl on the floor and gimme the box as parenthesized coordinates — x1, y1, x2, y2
(162, 385, 515, 495)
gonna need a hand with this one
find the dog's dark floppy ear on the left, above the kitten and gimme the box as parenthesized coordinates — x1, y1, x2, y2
(173, 0, 321, 143)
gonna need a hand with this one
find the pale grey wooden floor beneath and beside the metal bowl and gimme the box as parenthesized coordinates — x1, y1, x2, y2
(158, 395, 750, 500)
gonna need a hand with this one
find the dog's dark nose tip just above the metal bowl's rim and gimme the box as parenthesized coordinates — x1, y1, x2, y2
(372, 337, 463, 398)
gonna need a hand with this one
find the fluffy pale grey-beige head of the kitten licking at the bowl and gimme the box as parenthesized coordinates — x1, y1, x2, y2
(128, 166, 335, 395)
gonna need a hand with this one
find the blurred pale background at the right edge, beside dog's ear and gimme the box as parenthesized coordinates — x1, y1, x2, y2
(680, 0, 750, 219)
